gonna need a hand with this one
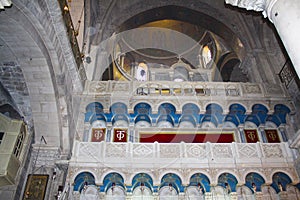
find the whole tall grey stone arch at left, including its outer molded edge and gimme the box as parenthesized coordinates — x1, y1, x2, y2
(1, 0, 82, 153)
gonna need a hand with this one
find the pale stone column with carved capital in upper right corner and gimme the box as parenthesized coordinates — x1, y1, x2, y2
(225, 0, 300, 77)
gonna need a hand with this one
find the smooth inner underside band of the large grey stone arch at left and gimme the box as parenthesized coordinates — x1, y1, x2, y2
(1, 2, 61, 146)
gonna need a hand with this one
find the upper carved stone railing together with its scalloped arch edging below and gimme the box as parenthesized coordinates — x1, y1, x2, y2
(83, 81, 294, 112)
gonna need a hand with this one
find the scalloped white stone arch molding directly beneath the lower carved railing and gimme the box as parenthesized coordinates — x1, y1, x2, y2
(66, 163, 298, 185)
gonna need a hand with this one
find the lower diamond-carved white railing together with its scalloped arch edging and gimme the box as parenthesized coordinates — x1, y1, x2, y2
(67, 142, 298, 184)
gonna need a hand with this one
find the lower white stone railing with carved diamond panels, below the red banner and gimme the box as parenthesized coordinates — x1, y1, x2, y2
(70, 141, 294, 169)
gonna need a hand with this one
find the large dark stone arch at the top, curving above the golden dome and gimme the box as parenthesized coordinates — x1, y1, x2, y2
(86, 0, 254, 82)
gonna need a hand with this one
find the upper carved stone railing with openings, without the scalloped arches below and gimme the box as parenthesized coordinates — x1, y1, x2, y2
(85, 81, 287, 98)
